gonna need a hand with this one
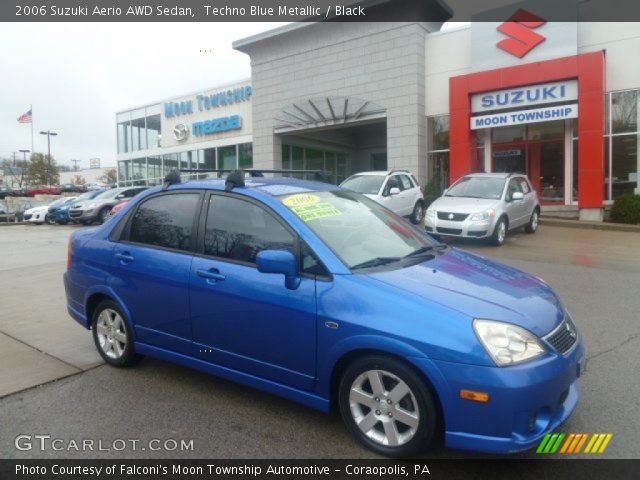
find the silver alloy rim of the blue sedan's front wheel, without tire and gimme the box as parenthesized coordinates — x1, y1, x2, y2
(349, 370, 420, 447)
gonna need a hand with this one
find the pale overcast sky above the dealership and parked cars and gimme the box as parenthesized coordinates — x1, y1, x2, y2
(0, 22, 464, 168)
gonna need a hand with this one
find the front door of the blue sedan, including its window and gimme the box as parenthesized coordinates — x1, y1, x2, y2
(190, 192, 316, 390)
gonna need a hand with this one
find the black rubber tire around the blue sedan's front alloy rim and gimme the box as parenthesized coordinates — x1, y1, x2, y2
(338, 355, 440, 458)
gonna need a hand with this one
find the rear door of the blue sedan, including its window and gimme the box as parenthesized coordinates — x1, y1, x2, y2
(111, 190, 203, 354)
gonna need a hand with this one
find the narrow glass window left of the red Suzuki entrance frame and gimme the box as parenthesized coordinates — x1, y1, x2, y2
(427, 115, 449, 195)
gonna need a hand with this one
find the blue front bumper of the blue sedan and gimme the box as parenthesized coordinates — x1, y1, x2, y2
(412, 343, 584, 453)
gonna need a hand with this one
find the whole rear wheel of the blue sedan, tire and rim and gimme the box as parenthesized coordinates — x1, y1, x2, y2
(91, 300, 142, 367)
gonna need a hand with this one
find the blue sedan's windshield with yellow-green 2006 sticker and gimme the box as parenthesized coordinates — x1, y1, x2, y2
(278, 190, 438, 270)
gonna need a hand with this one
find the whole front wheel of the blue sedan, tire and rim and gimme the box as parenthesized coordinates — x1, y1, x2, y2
(338, 356, 438, 457)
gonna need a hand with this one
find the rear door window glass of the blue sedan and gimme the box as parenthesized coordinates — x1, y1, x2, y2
(129, 192, 200, 251)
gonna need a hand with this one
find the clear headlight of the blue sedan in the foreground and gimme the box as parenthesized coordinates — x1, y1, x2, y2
(473, 319, 546, 367)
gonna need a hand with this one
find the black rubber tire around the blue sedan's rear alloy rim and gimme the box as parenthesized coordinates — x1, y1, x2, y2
(91, 300, 143, 368)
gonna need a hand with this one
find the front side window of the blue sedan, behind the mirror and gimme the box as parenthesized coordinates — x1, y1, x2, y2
(204, 195, 295, 264)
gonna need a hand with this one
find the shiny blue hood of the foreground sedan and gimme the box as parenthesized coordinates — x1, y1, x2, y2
(369, 248, 564, 336)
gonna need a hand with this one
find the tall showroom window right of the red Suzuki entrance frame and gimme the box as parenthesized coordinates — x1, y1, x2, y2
(607, 90, 640, 200)
